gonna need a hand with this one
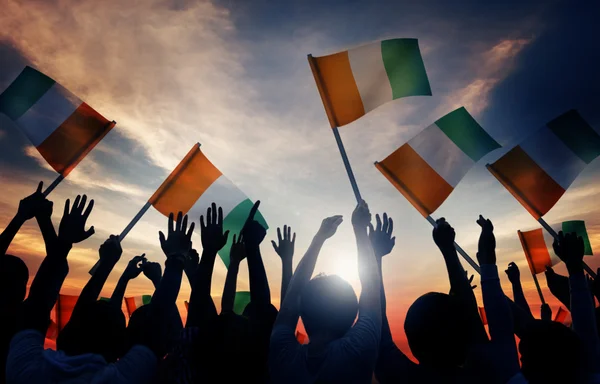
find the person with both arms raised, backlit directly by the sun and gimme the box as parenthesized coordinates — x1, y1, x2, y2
(269, 201, 381, 383)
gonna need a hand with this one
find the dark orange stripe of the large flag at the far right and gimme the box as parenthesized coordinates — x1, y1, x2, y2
(487, 145, 565, 220)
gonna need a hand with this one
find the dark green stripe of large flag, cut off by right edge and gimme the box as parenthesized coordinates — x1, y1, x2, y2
(547, 109, 600, 164)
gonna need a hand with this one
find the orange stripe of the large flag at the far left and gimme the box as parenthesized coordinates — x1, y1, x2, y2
(37, 103, 115, 177)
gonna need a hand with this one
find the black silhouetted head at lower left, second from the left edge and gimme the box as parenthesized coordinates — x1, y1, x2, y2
(56, 300, 125, 363)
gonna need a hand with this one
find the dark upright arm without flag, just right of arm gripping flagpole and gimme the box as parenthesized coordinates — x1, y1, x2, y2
(477, 215, 520, 383)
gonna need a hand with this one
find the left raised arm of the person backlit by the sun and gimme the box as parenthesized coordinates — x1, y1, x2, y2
(275, 215, 343, 329)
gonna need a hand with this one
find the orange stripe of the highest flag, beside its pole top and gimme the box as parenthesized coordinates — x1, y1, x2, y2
(309, 51, 365, 128)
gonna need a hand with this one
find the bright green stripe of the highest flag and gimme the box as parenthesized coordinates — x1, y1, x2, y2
(381, 39, 431, 99)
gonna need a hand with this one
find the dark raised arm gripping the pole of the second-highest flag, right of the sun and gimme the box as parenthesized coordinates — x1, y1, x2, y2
(433, 217, 488, 343)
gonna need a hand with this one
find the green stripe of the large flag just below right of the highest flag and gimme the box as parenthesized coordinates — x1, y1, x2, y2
(435, 107, 500, 162)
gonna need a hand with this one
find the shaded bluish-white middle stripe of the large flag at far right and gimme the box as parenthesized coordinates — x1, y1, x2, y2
(520, 127, 586, 190)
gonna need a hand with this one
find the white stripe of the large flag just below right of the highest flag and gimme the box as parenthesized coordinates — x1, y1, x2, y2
(408, 124, 475, 187)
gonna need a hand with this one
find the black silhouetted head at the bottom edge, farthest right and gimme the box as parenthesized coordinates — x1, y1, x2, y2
(519, 320, 585, 384)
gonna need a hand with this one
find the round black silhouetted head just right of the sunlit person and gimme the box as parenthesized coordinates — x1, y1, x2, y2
(404, 292, 470, 368)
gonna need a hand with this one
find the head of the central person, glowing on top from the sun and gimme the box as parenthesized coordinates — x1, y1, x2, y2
(300, 275, 358, 339)
